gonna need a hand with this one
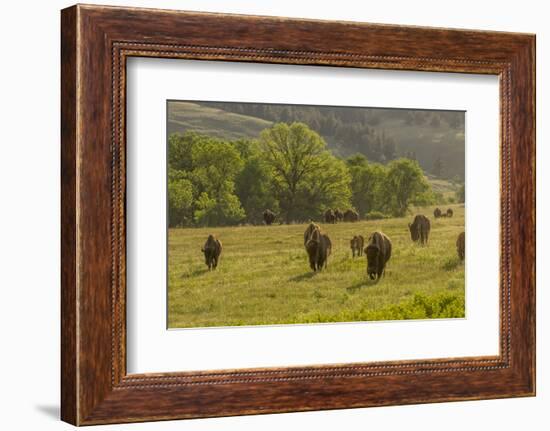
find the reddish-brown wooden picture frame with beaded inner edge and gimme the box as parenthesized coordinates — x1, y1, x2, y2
(61, 5, 535, 425)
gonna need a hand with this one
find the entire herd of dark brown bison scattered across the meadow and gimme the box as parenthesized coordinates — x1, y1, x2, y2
(201, 208, 466, 280)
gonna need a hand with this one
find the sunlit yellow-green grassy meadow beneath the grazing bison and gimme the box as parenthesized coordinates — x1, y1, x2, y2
(168, 205, 465, 328)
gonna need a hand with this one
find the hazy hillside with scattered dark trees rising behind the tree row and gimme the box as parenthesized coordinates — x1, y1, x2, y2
(168, 101, 465, 180)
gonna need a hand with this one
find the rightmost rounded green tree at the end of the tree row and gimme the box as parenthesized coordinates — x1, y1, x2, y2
(384, 159, 430, 217)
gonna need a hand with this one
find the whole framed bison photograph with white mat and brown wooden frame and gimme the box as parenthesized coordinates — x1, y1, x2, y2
(61, 5, 535, 425)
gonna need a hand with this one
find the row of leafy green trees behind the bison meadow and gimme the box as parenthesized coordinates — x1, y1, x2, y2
(168, 122, 458, 227)
